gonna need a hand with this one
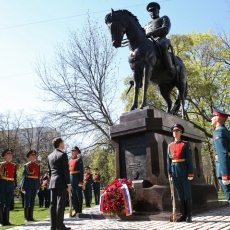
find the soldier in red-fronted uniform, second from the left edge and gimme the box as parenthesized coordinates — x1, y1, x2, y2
(21, 150, 40, 222)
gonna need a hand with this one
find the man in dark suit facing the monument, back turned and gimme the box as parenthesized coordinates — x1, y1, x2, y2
(48, 137, 71, 230)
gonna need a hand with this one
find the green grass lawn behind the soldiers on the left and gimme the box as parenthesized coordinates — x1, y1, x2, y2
(0, 197, 94, 230)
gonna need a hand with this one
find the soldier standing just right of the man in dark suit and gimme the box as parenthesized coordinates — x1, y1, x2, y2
(69, 146, 84, 217)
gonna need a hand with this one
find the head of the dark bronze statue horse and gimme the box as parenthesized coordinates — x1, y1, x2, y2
(105, 9, 126, 48)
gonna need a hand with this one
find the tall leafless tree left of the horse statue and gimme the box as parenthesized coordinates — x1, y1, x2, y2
(36, 18, 117, 149)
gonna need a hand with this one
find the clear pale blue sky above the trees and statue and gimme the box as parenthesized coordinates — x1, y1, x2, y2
(0, 0, 230, 113)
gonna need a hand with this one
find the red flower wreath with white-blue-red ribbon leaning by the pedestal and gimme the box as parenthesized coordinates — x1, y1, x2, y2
(99, 178, 136, 216)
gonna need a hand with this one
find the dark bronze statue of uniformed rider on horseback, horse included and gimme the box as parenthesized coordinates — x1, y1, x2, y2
(105, 2, 187, 119)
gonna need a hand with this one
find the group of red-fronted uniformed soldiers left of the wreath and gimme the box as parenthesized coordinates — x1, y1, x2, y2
(0, 140, 100, 229)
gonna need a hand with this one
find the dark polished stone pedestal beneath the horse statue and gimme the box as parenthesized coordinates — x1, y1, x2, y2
(110, 107, 218, 211)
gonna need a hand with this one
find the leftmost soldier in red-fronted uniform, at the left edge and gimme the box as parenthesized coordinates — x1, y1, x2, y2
(0, 148, 17, 226)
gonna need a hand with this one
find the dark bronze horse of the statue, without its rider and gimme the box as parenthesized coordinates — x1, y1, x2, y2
(105, 10, 187, 119)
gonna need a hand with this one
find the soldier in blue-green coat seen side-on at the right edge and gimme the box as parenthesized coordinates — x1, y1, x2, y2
(211, 107, 230, 205)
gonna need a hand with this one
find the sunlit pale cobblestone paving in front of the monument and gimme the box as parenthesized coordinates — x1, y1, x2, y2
(7, 206, 230, 230)
